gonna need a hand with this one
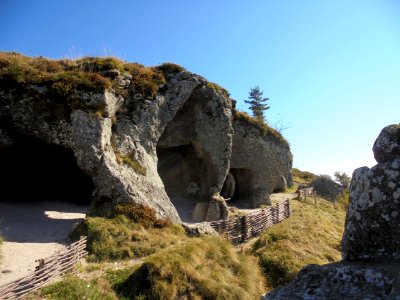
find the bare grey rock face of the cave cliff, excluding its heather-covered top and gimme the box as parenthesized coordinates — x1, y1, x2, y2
(0, 59, 292, 222)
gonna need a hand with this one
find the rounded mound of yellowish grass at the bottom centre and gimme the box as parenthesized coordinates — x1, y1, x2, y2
(120, 237, 265, 299)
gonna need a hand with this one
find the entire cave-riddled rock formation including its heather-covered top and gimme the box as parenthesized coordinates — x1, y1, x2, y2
(0, 53, 292, 222)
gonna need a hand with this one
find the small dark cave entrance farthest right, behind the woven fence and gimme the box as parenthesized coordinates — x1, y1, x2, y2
(221, 168, 252, 208)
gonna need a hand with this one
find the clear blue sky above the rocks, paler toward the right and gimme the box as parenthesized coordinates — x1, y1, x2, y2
(0, 0, 400, 174)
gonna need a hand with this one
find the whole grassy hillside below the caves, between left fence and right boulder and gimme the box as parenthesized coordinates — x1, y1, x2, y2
(20, 191, 345, 299)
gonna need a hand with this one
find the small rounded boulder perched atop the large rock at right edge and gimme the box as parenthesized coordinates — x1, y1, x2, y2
(372, 124, 400, 163)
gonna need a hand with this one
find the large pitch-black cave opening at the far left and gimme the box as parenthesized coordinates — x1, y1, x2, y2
(0, 135, 94, 205)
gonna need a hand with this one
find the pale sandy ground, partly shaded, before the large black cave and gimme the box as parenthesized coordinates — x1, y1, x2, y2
(0, 202, 89, 286)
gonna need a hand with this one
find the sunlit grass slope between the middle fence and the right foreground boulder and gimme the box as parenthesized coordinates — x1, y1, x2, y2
(252, 198, 346, 288)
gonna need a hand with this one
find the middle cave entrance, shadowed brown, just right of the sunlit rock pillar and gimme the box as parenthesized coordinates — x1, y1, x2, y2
(157, 144, 215, 222)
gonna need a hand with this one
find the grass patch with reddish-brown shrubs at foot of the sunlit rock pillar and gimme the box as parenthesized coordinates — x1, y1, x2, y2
(72, 203, 187, 261)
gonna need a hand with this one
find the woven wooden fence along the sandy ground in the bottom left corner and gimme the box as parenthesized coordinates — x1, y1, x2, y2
(0, 237, 87, 300)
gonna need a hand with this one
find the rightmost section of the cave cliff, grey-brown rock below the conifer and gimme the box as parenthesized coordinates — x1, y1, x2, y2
(230, 118, 293, 208)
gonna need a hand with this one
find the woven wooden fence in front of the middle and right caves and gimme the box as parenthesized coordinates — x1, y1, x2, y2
(210, 200, 290, 244)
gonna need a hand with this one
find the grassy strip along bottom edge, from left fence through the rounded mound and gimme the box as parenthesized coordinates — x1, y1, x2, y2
(35, 237, 265, 300)
